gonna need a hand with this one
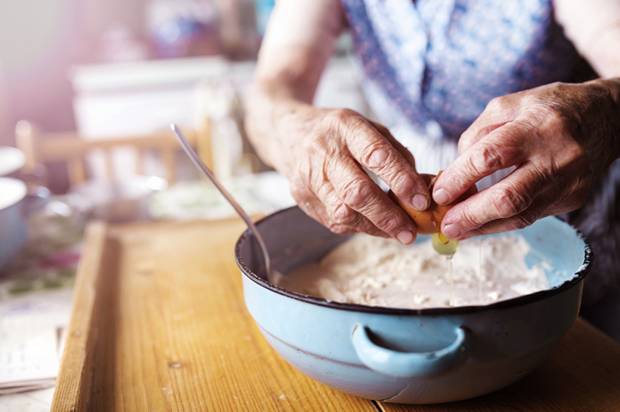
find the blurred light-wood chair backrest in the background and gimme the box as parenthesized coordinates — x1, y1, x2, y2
(15, 120, 213, 186)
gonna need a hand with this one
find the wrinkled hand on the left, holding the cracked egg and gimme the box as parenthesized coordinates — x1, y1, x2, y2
(272, 105, 430, 244)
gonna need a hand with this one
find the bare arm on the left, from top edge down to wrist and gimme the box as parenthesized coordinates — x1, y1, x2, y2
(246, 0, 344, 167)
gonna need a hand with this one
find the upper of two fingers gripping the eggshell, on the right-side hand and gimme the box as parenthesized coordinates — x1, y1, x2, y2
(433, 122, 529, 205)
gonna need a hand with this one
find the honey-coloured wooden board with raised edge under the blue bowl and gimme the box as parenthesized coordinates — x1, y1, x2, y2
(52, 221, 620, 412)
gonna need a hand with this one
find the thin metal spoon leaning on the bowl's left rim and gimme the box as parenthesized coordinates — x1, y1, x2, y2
(170, 123, 271, 276)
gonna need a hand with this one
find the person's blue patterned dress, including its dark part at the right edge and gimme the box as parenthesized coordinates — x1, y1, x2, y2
(341, 0, 620, 308)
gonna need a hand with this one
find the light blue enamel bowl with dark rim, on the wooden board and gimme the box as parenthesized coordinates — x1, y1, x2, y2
(235, 207, 590, 404)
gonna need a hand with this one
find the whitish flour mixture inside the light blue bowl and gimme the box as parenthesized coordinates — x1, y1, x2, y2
(272, 234, 549, 309)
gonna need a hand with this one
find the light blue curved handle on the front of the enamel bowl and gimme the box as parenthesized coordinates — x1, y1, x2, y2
(351, 323, 468, 378)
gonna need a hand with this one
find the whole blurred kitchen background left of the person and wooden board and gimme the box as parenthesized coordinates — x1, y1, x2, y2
(0, 0, 368, 404)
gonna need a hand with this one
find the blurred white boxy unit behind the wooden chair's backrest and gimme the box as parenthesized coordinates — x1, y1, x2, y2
(72, 57, 228, 179)
